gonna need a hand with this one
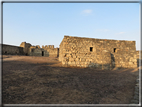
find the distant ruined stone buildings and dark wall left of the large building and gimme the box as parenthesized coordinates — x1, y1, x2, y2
(2, 42, 59, 57)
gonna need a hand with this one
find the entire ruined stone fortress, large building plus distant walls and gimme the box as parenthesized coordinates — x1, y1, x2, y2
(2, 36, 140, 69)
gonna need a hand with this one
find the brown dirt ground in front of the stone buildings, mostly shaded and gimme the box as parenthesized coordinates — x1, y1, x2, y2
(2, 55, 138, 104)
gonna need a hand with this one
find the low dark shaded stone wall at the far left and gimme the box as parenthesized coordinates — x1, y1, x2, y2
(2, 44, 24, 55)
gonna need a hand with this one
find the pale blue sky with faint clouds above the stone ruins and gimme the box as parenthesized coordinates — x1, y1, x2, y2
(3, 3, 140, 50)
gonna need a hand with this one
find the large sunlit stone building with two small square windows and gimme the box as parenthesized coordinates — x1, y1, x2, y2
(59, 36, 137, 69)
